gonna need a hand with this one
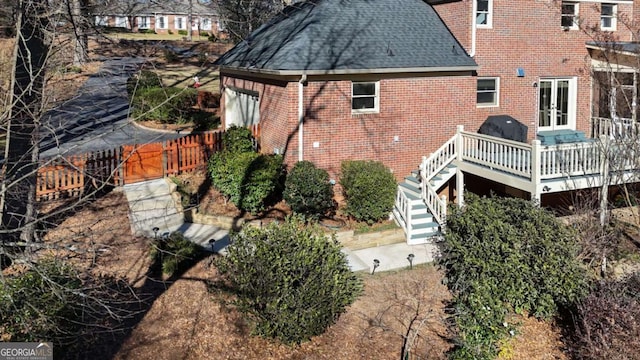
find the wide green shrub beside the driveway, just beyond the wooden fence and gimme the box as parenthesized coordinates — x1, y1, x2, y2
(132, 88, 198, 124)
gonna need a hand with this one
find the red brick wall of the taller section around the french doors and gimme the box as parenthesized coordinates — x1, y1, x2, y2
(434, 0, 640, 138)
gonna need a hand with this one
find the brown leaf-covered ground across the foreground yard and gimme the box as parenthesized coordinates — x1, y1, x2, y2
(35, 188, 566, 360)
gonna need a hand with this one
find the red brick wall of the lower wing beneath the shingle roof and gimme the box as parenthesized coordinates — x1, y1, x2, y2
(222, 75, 479, 180)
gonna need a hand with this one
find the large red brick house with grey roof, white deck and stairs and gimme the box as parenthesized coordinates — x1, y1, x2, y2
(218, 0, 640, 243)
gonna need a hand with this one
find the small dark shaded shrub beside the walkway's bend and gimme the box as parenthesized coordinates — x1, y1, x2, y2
(149, 232, 202, 276)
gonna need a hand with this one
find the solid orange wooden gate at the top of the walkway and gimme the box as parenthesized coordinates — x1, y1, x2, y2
(122, 142, 164, 184)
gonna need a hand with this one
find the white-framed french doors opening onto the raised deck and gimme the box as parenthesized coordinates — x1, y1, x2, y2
(538, 78, 576, 131)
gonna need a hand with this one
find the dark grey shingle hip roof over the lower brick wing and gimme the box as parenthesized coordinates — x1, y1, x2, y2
(216, 0, 477, 75)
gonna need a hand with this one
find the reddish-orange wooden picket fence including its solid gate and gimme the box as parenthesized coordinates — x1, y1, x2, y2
(36, 125, 260, 201)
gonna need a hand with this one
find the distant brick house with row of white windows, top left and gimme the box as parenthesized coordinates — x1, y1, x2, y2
(95, 0, 222, 36)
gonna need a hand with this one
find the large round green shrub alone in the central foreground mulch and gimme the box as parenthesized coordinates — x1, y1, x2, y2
(217, 217, 362, 343)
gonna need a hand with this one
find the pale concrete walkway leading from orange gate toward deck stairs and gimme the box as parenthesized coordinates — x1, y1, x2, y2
(123, 179, 437, 273)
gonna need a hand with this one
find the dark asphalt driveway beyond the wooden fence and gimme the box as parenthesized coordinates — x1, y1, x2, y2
(40, 58, 184, 158)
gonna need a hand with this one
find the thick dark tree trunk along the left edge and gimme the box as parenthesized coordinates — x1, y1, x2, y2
(0, 0, 48, 242)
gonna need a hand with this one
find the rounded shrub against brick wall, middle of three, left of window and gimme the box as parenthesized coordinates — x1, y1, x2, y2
(283, 161, 335, 219)
